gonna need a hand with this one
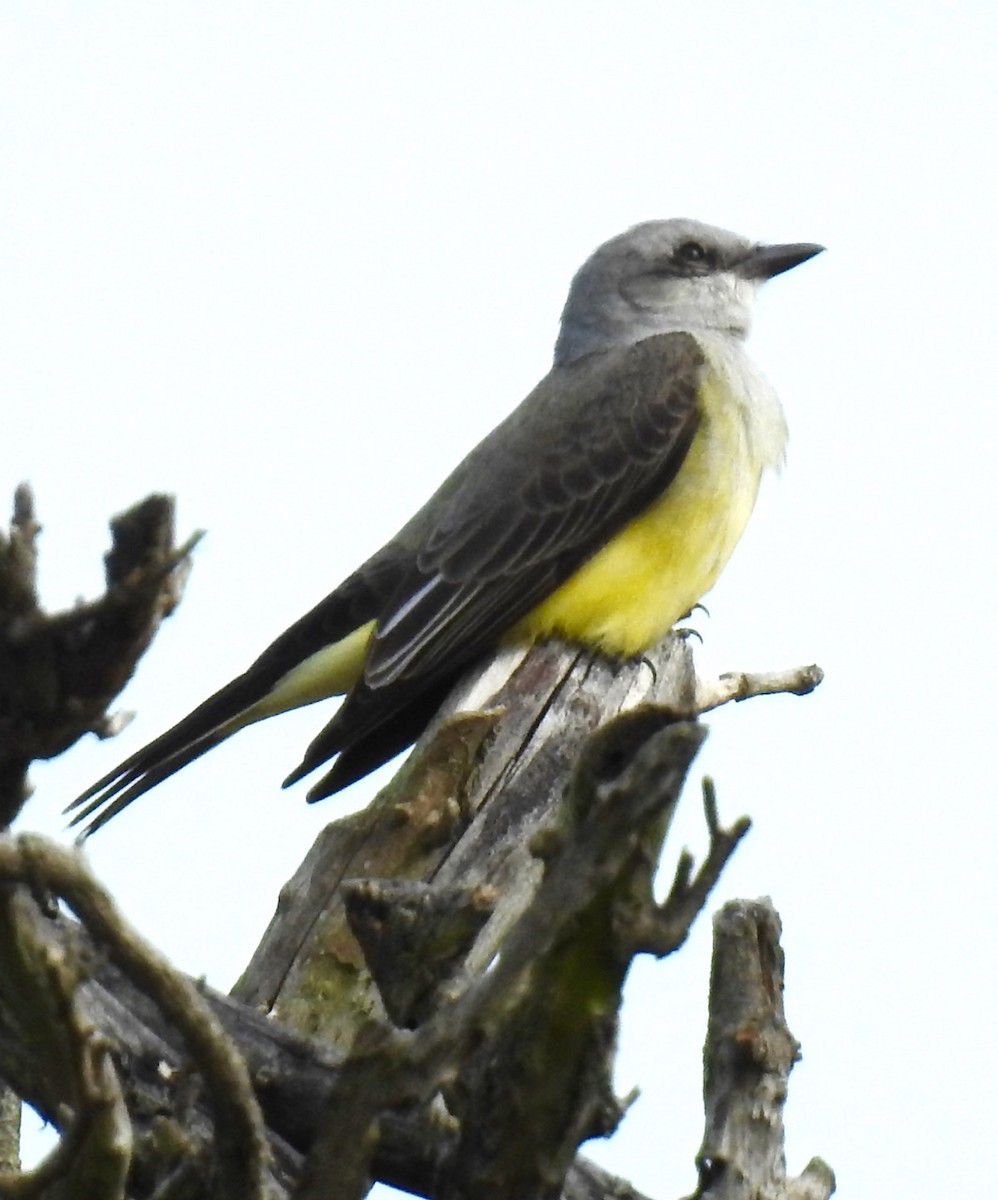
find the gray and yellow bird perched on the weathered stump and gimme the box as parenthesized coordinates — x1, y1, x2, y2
(66, 218, 824, 838)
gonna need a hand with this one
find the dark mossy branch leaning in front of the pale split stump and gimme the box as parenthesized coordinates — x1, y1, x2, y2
(300, 706, 704, 1200)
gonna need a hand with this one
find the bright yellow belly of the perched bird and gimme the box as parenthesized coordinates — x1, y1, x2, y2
(510, 383, 763, 656)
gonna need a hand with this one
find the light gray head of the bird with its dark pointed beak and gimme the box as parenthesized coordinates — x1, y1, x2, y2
(554, 220, 823, 366)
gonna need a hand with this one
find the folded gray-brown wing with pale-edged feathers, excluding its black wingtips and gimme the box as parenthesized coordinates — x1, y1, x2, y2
(365, 334, 704, 689)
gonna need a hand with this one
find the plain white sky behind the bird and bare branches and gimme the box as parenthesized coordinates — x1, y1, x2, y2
(0, 0, 998, 1198)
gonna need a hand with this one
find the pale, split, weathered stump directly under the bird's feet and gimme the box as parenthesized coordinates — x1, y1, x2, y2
(233, 637, 696, 1048)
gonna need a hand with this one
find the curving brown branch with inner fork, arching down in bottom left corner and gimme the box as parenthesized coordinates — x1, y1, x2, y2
(0, 835, 269, 1200)
